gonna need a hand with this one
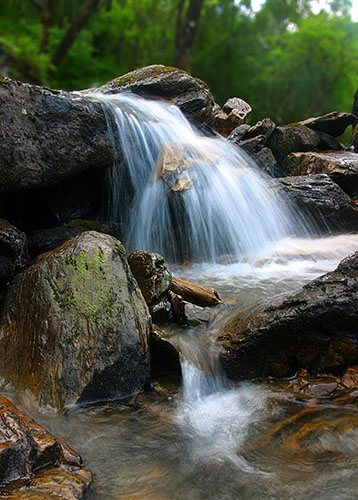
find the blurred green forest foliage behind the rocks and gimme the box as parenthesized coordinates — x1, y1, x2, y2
(0, 0, 358, 124)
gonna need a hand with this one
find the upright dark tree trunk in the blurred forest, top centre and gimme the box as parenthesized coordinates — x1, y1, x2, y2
(174, 0, 204, 71)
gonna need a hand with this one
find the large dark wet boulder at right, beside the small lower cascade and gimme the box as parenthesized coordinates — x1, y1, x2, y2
(216, 252, 358, 380)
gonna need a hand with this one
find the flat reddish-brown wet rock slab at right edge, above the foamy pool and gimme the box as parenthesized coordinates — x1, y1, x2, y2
(282, 151, 358, 196)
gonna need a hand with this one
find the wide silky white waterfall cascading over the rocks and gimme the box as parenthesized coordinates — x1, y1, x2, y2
(89, 93, 304, 262)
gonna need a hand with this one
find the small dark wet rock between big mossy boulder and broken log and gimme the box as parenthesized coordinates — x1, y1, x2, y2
(128, 250, 172, 305)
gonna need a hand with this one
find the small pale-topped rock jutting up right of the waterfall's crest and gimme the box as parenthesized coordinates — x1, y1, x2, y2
(214, 97, 252, 137)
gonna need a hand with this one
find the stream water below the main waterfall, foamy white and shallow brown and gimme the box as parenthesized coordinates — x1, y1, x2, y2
(6, 235, 358, 500)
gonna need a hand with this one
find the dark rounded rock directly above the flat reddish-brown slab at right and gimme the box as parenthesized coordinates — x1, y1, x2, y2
(266, 124, 342, 164)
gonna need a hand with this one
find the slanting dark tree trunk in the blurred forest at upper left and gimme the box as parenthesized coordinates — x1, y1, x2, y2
(51, 0, 102, 66)
